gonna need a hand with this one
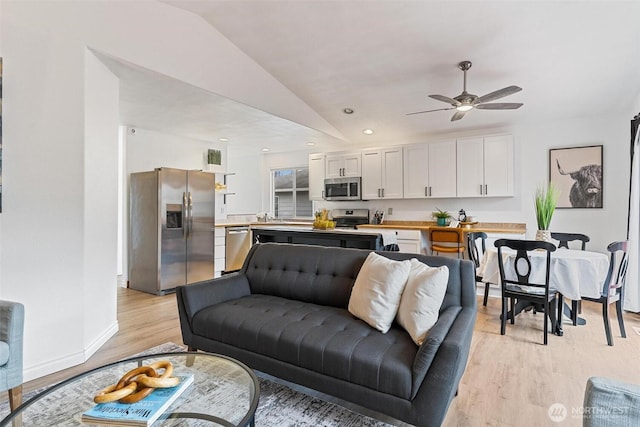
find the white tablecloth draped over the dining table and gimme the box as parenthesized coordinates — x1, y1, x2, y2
(478, 248, 609, 300)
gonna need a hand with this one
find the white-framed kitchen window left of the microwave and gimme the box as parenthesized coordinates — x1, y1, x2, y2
(272, 167, 313, 218)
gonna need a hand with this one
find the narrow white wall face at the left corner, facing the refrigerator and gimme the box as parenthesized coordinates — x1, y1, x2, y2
(80, 49, 119, 359)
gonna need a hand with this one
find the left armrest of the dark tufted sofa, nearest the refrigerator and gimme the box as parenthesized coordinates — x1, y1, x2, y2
(176, 273, 251, 324)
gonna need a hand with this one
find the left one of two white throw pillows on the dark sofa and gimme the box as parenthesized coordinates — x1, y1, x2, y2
(349, 252, 411, 334)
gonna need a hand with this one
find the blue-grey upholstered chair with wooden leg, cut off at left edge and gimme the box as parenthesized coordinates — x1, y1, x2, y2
(0, 301, 24, 411)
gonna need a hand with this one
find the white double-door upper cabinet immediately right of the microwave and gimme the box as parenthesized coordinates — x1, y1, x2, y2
(362, 147, 403, 200)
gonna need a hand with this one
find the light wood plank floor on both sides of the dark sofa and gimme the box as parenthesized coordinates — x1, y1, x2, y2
(8, 288, 640, 427)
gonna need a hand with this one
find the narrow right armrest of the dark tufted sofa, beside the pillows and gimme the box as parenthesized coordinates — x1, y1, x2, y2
(412, 306, 462, 397)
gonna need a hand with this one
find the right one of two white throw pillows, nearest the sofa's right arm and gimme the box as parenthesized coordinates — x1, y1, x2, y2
(398, 258, 449, 345)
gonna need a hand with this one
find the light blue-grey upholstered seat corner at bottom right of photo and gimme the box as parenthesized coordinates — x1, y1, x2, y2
(582, 377, 640, 427)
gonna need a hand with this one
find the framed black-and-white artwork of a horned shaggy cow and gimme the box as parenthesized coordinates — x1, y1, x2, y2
(549, 145, 603, 208)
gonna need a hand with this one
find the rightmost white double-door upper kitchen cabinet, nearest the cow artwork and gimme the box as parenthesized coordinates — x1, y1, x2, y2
(457, 135, 513, 197)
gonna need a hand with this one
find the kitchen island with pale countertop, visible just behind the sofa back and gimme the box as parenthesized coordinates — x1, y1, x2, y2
(251, 225, 398, 251)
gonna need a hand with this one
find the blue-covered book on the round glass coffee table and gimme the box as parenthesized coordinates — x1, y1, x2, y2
(82, 374, 193, 426)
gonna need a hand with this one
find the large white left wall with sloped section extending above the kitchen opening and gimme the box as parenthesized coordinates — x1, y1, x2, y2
(0, 1, 335, 380)
